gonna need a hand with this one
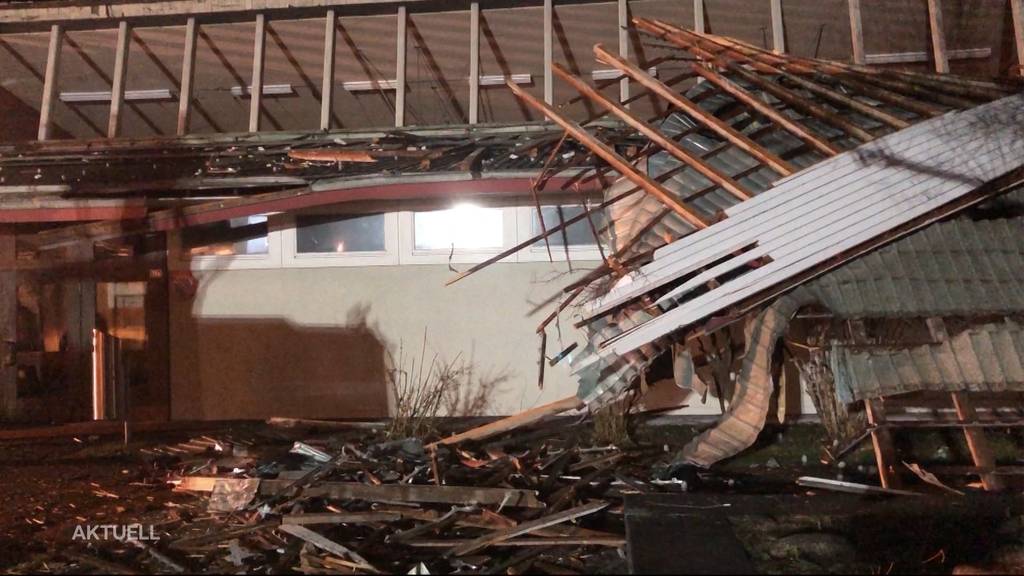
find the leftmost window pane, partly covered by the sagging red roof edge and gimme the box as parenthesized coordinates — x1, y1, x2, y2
(181, 215, 270, 256)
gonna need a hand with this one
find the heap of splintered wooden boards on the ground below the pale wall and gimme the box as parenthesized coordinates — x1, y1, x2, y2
(138, 420, 679, 574)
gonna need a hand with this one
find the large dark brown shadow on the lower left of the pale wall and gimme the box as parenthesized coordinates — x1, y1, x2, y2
(172, 308, 388, 420)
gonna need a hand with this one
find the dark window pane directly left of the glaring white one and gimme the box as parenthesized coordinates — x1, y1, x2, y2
(295, 214, 386, 254)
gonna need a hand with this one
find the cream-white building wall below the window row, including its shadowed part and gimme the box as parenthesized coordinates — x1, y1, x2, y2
(171, 262, 606, 419)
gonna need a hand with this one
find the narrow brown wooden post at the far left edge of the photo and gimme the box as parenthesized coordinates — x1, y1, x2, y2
(0, 230, 18, 420)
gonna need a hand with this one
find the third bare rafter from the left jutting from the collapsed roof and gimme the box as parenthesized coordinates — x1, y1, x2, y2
(594, 44, 796, 176)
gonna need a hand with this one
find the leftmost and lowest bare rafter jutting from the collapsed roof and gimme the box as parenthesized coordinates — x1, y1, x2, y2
(506, 79, 708, 230)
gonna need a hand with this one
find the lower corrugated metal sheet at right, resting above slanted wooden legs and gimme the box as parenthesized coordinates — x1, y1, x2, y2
(828, 321, 1024, 403)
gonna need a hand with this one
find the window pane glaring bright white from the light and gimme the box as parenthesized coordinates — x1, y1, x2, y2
(413, 204, 504, 250)
